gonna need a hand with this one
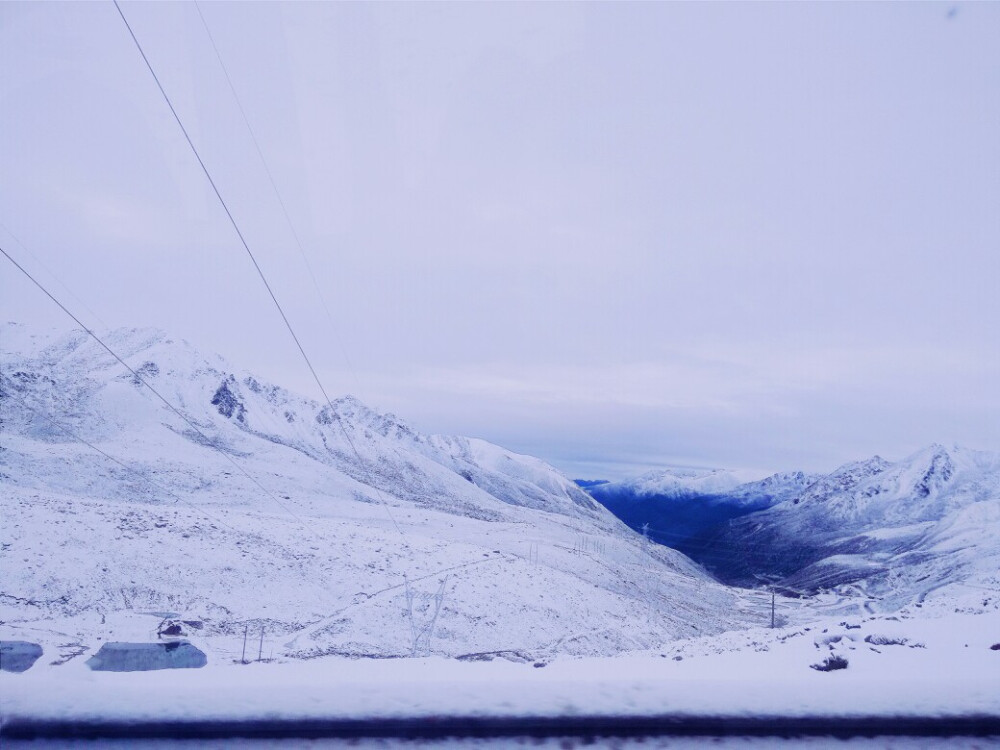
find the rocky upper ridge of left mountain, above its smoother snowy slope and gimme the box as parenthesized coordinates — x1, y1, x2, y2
(4, 324, 606, 520)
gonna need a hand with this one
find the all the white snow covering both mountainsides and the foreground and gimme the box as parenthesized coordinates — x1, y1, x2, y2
(0, 326, 1000, 721)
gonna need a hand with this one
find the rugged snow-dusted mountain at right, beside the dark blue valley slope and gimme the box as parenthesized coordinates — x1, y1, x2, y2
(695, 445, 1000, 605)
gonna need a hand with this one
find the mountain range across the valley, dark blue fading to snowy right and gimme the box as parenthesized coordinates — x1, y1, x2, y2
(589, 445, 1000, 595)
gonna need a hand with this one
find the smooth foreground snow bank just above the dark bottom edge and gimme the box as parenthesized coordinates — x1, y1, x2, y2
(0, 612, 1000, 722)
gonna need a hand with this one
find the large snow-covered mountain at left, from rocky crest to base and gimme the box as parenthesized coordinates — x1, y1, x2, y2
(0, 324, 748, 658)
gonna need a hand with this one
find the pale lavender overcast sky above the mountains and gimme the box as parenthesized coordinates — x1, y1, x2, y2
(0, 2, 1000, 477)
